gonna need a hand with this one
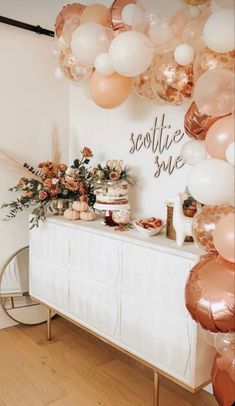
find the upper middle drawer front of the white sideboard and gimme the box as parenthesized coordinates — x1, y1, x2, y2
(69, 230, 121, 287)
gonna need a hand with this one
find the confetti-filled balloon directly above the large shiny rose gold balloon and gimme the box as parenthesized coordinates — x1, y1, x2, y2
(192, 206, 234, 252)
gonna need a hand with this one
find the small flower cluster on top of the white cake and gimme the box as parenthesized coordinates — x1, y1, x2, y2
(92, 160, 136, 186)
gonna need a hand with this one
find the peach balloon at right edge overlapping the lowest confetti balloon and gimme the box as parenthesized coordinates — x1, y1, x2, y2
(213, 213, 235, 263)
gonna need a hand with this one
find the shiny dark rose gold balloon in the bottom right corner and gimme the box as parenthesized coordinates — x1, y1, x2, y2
(211, 354, 235, 406)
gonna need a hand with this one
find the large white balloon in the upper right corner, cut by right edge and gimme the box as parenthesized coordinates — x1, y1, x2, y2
(203, 9, 235, 53)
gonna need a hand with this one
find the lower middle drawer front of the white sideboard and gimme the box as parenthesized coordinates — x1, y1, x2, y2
(69, 272, 119, 338)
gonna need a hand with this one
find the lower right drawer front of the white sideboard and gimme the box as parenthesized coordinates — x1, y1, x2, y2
(120, 294, 192, 381)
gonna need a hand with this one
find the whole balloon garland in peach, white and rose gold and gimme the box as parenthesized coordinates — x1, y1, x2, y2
(52, 0, 235, 406)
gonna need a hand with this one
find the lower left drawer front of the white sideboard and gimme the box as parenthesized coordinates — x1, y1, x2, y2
(30, 256, 69, 311)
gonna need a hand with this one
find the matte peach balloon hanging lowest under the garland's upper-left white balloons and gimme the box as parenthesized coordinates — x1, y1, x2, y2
(90, 71, 132, 109)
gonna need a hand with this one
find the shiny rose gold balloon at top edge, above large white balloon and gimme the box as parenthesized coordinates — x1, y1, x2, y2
(108, 0, 137, 31)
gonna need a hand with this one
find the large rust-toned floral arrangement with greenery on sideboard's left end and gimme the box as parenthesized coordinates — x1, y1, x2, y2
(2, 147, 95, 229)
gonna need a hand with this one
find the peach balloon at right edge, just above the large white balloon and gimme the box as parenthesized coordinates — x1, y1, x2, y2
(205, 116, 234, 160)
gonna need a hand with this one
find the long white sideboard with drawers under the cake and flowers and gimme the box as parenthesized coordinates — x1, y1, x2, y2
(30, 217, 215, 391)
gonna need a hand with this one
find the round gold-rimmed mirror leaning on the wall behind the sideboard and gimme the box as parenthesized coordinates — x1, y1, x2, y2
(0, 247, 47, 325)
